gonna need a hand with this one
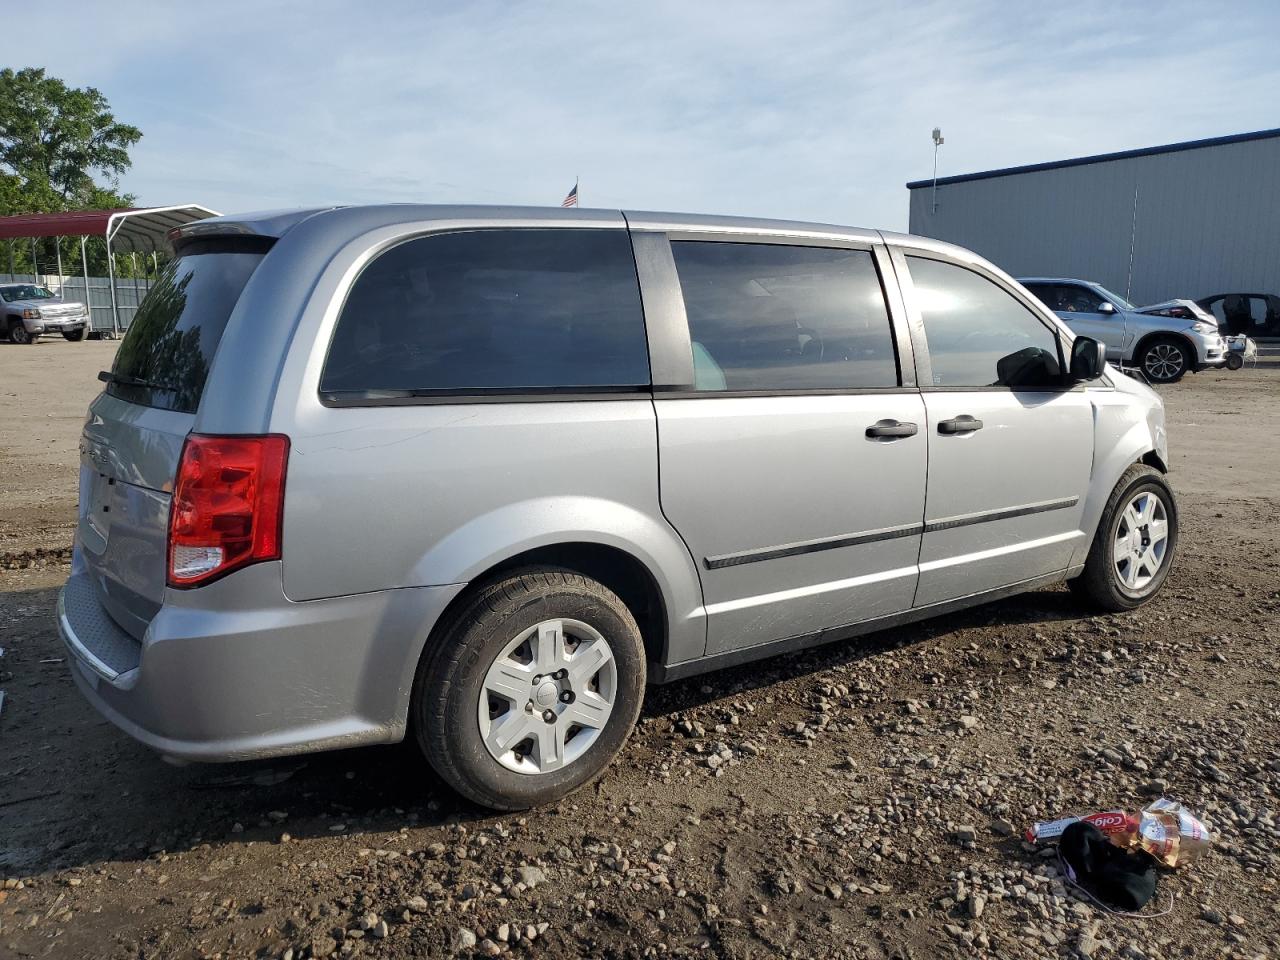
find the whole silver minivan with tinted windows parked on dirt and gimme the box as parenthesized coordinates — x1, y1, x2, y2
(59, 205, 1178, 809)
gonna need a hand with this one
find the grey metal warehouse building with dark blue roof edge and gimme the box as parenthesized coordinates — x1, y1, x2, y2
(906, 129, 1280, 325)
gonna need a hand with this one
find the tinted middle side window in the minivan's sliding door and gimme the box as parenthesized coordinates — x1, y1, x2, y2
(671, 241, 899, 392)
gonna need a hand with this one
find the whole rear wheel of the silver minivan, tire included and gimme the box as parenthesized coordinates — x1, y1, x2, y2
(412, 567, 645, 810)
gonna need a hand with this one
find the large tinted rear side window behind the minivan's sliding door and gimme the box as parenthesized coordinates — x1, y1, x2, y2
(320, 229, 649, 401)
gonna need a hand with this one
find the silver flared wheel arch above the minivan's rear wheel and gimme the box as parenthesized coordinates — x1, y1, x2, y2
(410, 497, 707, 662)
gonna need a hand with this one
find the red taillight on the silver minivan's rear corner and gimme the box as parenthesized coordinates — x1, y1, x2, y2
(168, 434, 289, 588)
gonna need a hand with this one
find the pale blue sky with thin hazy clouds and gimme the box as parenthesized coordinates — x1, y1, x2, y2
(27, 0, 1280, 229)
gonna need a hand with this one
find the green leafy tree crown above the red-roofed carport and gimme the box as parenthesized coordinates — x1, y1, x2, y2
(0, 67, 142, 212)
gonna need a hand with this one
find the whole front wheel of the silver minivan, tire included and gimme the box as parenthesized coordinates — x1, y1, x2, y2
(1071, 463, 1178, 613)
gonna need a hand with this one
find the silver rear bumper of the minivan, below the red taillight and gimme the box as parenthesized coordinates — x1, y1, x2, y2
(58, 563, 462, 760)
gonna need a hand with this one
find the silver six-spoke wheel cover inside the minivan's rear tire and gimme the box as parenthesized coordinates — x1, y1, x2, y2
(477, 618, 618, 774)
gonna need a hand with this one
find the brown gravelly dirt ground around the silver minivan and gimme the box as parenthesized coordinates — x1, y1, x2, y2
(0, 342, 1280, 960)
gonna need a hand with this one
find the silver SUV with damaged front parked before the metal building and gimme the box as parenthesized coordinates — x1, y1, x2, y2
(1019, 276, 1226, 383)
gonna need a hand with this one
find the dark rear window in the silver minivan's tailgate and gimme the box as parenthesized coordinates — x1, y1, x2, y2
(106, 238, 270, 413)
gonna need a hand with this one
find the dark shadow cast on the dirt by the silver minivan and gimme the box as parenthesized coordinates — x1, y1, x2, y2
(0, 580, 1088, 877)
